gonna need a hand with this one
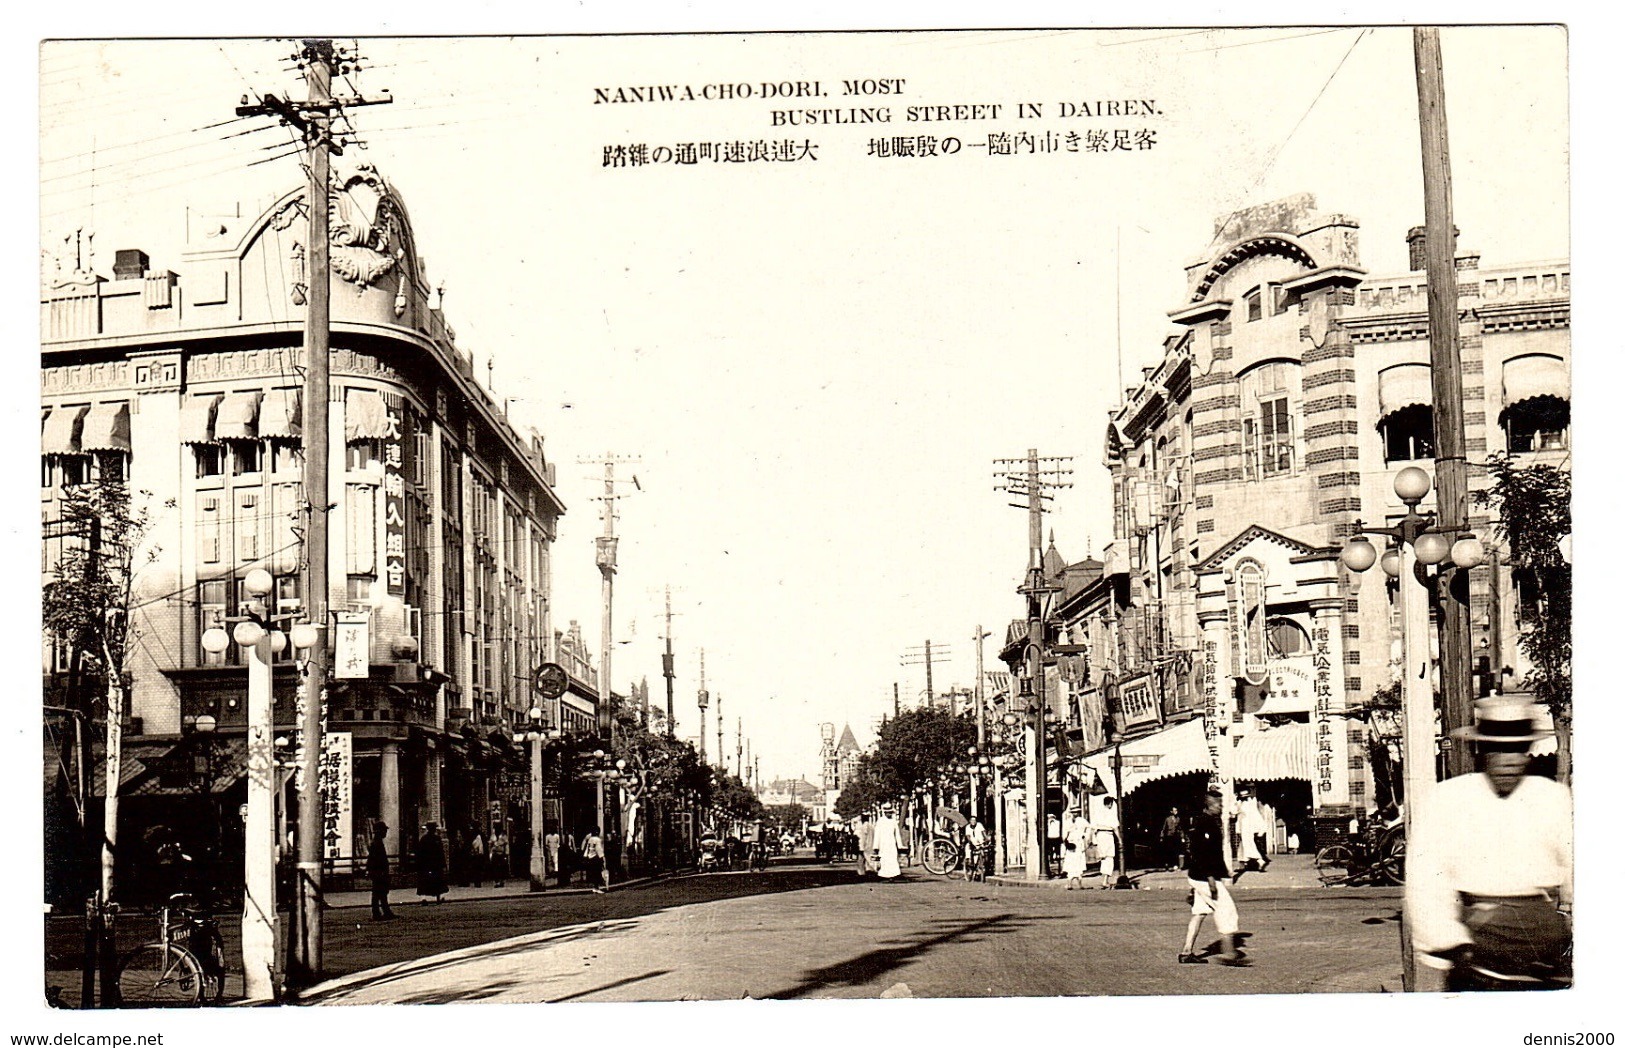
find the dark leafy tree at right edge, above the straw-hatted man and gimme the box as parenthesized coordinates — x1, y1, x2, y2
(1472, 455, 1573, 778)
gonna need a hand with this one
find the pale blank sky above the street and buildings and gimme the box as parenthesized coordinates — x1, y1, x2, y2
(39, 28, 1570, 778)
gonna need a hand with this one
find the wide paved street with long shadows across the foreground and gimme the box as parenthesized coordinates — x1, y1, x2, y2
(306, 866, 1399, 1004)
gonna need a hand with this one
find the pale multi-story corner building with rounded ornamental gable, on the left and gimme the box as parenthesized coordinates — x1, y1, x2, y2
(41, 167, 596, 883)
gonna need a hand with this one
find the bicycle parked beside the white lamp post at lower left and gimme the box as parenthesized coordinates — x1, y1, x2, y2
(119, 892, 226, 1007)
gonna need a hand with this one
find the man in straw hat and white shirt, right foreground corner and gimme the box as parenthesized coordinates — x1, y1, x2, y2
(1406, 697, 1575, 990)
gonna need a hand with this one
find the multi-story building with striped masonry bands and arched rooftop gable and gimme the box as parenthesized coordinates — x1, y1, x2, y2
(1063, 195, 1570, 857)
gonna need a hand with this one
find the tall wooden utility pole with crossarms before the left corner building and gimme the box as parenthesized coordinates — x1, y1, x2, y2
(237, 39, 392, 986)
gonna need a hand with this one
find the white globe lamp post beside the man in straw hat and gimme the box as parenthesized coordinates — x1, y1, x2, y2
(1342, 466, 1485, 990)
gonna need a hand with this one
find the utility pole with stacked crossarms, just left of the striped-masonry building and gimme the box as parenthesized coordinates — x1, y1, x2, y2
(995, 448, 1073, 881)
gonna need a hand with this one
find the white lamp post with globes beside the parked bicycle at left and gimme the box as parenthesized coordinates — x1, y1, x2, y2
(203, 569, 319, 1003)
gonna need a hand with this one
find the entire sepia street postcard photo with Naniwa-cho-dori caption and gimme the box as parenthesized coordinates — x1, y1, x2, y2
(28, 24, 1586, 1043)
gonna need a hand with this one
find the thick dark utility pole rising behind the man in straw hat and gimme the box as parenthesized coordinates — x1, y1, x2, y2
(1411, 26, 1500, 775)
